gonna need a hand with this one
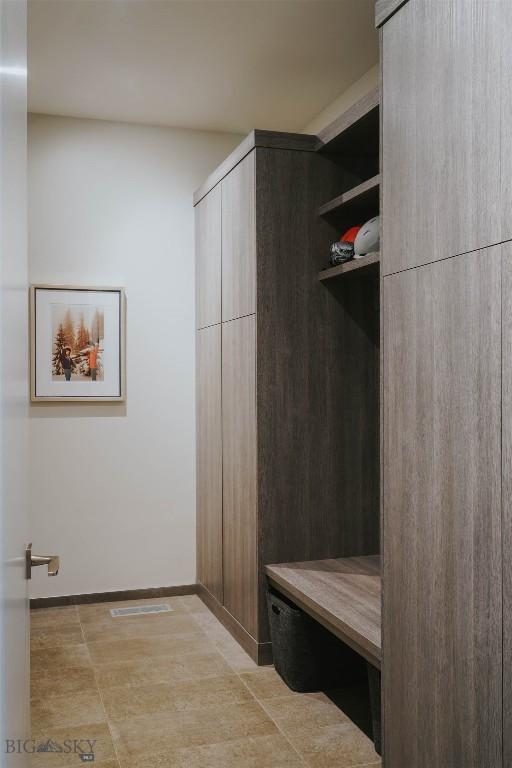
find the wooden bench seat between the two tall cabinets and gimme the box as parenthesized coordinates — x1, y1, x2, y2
(265, 555, 381, 669)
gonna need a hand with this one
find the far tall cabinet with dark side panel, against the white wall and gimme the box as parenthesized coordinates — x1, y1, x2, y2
(195, 131, 378, 663)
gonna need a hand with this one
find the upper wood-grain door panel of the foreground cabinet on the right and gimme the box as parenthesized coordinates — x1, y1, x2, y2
(382, 0, 500, 274)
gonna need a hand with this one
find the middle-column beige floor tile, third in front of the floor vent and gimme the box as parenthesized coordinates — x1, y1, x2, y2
(94, 652, 232, 690)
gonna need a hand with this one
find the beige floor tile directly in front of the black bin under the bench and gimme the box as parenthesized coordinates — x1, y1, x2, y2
(262, 693, 350, 736)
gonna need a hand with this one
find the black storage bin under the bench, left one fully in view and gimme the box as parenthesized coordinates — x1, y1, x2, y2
(267, 590, 366, 693)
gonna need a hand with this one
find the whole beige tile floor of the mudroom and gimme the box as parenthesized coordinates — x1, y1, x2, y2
(31, 596, 380, 768)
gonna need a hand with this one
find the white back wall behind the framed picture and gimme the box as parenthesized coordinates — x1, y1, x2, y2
(29, 115, 241, 597)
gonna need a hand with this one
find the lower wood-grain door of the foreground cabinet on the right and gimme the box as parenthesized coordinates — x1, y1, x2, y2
(383, 246, 502, 768)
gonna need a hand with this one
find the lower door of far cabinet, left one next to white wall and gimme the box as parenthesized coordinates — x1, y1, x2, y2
(196, 325, 222, 603)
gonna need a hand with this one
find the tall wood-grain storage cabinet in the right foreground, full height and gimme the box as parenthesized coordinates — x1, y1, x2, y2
(381, 0, 512, 768)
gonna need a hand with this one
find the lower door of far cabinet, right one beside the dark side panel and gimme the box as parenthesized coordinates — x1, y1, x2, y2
(222, 315, 258, 639)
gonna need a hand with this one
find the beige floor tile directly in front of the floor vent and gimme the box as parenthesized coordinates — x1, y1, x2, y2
(83, 614, 204, 643)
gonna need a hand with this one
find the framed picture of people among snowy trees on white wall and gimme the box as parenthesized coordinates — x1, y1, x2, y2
(30, 285, 126, 402)
